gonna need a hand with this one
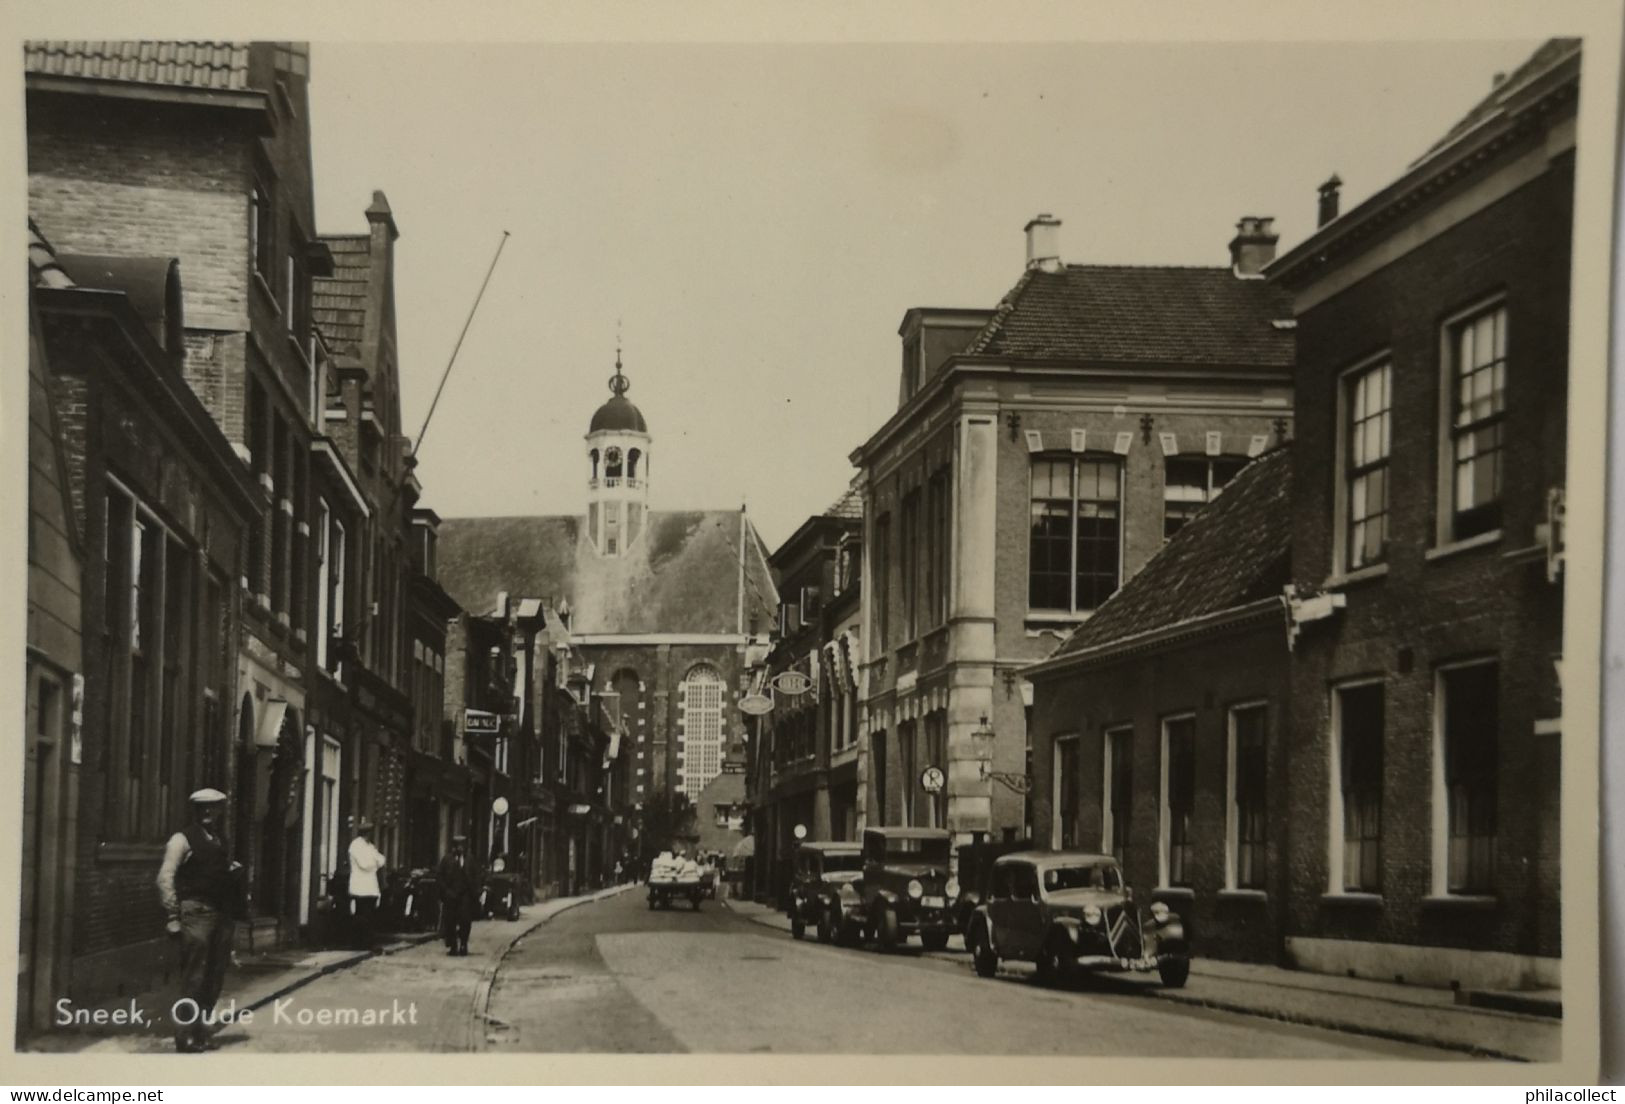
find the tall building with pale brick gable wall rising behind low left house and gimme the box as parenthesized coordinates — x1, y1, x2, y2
(24, 42, 332, 943)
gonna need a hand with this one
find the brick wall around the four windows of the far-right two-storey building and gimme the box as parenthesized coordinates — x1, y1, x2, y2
(1287, 158, 1573, 954)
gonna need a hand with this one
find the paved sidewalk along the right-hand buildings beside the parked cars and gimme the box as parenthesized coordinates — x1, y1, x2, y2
(722, 899, 1563, 1062)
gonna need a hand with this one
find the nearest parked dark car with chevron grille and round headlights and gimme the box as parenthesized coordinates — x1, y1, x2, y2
(967, 850, 1191, 989)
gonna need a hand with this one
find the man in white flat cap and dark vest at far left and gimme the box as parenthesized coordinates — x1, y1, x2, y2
(158, 789, 242, 1052)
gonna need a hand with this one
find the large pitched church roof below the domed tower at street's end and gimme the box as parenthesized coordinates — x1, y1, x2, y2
(437, 511, 778, 634)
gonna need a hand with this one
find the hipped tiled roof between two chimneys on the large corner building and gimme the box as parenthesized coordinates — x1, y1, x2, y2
(965, 265, 1294, 369)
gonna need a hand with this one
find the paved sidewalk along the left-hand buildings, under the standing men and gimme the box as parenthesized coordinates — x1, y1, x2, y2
(30, 886, 627, 1054)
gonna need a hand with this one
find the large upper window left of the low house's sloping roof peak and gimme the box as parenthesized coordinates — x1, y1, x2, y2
(1027, 457, 1121, 613)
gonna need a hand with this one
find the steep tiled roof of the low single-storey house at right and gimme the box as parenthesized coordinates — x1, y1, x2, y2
(1055, 447, 1292, 655)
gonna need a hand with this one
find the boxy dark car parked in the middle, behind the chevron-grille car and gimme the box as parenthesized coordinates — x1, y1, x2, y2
(863, 828, 959, 951)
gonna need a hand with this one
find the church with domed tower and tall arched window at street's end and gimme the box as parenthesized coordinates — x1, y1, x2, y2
(440, 367, 778, 883)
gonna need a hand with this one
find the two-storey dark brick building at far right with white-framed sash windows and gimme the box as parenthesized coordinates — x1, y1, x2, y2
(1269, 41, 1580, 987)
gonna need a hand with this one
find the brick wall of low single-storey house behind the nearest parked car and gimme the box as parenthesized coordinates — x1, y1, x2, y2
(1032, 618, 1297, 961)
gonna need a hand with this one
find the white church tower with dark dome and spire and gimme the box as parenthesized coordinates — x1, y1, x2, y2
(587, 350, 648, 556)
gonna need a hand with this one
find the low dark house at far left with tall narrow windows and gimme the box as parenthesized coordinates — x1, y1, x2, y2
(20, 222, 263, 1008)
